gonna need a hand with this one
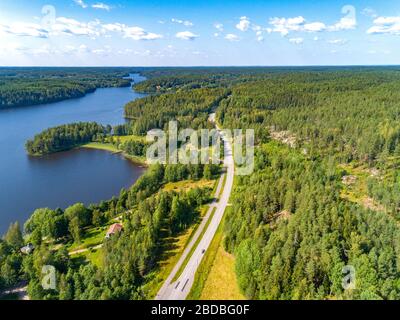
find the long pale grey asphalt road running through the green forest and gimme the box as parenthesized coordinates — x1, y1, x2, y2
(155, 122, 235, 300)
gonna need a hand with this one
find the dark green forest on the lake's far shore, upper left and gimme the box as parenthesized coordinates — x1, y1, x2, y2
(0, 68, 131, 109)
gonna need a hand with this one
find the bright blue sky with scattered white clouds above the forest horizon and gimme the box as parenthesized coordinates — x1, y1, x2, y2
(0, 0, 400, 66)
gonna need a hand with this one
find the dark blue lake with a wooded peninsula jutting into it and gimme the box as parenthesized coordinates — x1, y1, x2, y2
(0, 74, 145, 235)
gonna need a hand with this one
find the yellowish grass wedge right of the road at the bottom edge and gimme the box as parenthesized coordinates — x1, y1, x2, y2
(200, 243, 245, 300)
